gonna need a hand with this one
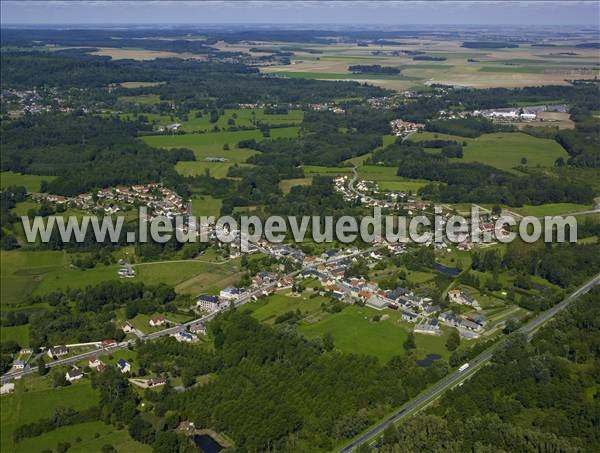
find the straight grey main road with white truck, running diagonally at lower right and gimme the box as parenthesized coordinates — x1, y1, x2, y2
(340, 274, 600, 453)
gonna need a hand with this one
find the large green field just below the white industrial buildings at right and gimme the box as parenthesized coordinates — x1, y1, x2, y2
(410, 132, 569, 172)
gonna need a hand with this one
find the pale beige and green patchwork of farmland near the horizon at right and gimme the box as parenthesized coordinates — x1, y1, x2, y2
(253, 39, 599, 91)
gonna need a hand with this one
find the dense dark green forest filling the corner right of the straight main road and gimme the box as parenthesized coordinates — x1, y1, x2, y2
(379, 289, 600, 452)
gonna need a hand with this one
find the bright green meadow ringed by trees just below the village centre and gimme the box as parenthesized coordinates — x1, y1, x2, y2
(299, 306, 408, 362)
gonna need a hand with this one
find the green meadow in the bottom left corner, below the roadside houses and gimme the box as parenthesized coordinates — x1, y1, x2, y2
(0, 376, 98, 451)
